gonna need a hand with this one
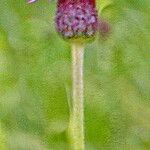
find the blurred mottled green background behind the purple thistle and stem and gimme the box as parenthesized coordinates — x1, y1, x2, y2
(0, 0, 150, 150)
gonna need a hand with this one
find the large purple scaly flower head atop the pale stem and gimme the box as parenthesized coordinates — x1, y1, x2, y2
(56, 0, 98, 40)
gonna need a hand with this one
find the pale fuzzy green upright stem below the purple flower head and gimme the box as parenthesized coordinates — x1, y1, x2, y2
(69, 43, 84, 150)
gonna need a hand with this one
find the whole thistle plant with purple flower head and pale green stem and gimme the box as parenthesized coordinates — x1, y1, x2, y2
(28, 0, 108, 150)
